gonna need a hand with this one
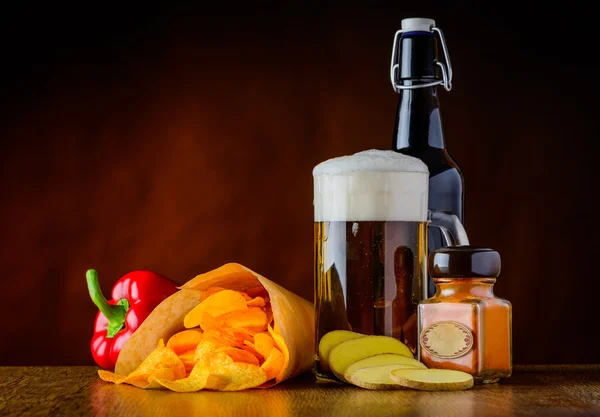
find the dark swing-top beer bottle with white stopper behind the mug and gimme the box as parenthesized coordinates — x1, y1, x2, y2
(390, 18, 464, 296)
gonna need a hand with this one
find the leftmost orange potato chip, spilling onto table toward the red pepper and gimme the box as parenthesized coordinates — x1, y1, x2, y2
(98, 339, 186, 388)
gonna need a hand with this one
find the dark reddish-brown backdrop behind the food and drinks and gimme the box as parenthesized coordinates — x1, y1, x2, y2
(0, 2, 600, 365)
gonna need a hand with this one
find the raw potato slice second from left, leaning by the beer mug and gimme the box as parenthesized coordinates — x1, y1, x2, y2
(329, 336, 413, 381)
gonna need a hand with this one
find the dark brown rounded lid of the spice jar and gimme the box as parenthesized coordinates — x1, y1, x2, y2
(429, 245, 500, 278)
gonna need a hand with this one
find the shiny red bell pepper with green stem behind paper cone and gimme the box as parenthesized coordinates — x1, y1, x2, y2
(86, 269, 177, 370)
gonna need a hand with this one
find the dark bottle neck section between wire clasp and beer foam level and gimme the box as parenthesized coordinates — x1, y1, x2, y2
(393, 87, 445, 151)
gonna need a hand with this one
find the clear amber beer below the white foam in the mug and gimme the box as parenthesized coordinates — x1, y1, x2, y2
(314, 221, 427, 377)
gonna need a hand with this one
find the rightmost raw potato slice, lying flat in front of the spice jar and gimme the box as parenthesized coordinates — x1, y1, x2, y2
(390, 369, 473, 391)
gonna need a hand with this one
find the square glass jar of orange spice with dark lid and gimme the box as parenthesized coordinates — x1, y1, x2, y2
(418, 246, 512, 384)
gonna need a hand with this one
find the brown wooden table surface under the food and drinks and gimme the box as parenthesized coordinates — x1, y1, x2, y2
(0, 365, 600, 417)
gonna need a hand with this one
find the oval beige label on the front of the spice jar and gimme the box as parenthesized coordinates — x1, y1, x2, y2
(420, 321, 473, 359)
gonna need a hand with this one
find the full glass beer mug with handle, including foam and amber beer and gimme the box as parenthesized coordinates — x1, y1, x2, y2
(313, 150, 469, 379)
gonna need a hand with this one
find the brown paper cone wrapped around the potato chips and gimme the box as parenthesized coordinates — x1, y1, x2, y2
(115, 263, 315, 385)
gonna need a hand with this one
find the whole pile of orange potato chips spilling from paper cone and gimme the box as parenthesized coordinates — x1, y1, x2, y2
(98, 287, 289, 392)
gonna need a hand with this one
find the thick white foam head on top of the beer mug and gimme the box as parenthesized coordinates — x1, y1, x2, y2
(313, 149, 429, 222)
